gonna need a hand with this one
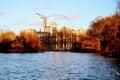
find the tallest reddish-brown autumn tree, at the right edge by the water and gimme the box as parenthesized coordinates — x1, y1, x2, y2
(88, 14, 120, 53)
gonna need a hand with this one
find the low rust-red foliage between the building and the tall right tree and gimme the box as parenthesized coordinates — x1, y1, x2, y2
(72, 35, 101, 52)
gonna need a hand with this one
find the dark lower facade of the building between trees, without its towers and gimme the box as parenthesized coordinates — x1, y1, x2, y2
(37, 27, 77, 51)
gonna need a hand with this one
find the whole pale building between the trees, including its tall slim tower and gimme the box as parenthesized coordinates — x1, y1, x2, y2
(37, 14, 86, 51)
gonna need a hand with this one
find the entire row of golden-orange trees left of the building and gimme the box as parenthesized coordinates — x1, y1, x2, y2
(0, 30, 46, 53)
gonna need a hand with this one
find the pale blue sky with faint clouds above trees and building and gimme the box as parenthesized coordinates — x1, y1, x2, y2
(0, 0, 116, 33)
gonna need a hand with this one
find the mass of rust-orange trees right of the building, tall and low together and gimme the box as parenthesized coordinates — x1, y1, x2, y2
(72, 14, 120, 54)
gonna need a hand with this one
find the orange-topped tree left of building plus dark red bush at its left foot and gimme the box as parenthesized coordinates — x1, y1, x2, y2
(9, 30, 46, 53)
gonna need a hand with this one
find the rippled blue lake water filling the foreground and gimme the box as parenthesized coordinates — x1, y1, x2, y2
(0, 52, 120, 80)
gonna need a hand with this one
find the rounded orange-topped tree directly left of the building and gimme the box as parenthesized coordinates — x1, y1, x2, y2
(19, 30, 46, 52)
